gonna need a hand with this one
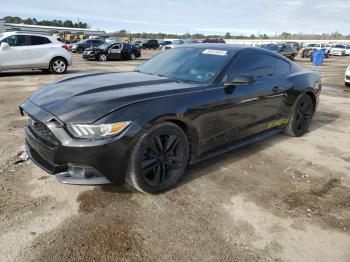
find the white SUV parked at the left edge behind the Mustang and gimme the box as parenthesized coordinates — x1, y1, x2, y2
(0, 32, 72, 74)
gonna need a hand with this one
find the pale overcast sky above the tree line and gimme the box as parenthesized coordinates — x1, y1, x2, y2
(0, 0, 350, 34)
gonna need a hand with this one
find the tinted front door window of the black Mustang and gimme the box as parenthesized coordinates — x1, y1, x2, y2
(235, 53, 275, 80)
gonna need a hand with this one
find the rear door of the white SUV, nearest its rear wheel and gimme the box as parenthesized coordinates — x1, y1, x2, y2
(28, 36, 55, 68)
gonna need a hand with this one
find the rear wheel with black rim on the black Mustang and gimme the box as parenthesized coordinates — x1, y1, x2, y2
(284, 94, 314, 137)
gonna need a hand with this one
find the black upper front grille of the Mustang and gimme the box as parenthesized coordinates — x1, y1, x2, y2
(28, 117, 59, 147)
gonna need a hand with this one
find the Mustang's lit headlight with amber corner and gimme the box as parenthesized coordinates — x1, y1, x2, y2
(68, 121, 131, 138)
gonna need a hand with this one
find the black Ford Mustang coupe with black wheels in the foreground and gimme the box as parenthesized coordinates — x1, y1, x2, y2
(20, 44, 321, 193)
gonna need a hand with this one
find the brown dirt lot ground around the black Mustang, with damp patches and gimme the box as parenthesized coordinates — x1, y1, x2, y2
(0, 51, 350, 262)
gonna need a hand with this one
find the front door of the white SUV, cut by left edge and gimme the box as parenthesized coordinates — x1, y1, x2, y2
(0, 35, 30, 70)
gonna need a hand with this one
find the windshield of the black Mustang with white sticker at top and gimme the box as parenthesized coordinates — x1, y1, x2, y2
(138, 47, 233, 83)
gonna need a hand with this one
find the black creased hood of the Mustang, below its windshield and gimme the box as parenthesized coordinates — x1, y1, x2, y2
(29, 72, 199, 124)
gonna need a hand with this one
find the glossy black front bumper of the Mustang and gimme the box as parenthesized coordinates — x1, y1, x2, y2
(21, 101, 142, 185)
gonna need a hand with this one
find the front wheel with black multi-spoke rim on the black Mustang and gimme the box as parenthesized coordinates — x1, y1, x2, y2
(126, 122, 189, 194)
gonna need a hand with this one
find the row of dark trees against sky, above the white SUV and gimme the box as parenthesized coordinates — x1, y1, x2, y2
(3, 16, 88, 28)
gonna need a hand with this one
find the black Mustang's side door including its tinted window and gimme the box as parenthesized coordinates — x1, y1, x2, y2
(216, 52, 289, 144)
